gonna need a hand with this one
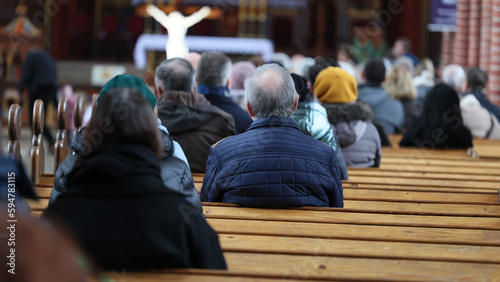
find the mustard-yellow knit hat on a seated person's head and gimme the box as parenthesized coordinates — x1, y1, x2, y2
(314, 67, 358, 104)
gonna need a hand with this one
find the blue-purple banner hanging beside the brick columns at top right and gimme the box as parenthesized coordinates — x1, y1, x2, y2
(428, 0, 457, 32)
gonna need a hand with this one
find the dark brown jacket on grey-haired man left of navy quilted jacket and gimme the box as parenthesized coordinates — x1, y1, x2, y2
(158, 91, 235, 173)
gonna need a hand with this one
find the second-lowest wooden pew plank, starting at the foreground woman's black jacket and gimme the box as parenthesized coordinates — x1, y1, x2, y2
(219, 233, 500, 263)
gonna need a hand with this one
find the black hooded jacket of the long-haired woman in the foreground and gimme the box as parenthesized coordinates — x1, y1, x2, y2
(43, 144, 226, 270)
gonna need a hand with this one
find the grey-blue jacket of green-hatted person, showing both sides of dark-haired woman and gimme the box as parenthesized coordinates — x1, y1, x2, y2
(49, 129, 202, 213)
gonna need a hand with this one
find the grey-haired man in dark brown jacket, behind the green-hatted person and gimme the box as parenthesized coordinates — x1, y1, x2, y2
(155, 58, 235, 173)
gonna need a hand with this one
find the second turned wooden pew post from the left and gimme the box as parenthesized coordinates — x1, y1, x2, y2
(30, 100, 45, 184)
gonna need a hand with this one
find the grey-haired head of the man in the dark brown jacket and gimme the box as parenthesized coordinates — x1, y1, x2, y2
(155, 58, 195, 92)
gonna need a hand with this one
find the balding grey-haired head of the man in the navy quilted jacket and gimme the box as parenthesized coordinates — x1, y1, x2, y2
(245, 64, 298, 118)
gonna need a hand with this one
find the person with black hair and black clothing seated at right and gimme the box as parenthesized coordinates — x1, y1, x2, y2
(399, 84, 472, 149)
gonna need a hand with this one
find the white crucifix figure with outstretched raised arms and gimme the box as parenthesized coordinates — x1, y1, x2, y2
(146, 4, 212, 59)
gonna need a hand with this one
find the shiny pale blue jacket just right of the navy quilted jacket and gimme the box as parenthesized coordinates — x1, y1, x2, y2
(292, 102, 349, 180)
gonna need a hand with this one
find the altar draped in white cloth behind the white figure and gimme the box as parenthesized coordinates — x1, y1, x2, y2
(134, 34, 274, 69)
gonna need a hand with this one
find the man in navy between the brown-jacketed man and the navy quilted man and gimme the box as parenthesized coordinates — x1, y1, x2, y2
(196, 52, 252, 134)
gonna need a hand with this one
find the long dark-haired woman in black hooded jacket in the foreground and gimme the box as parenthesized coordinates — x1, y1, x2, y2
(44, 88, 226, 270)
